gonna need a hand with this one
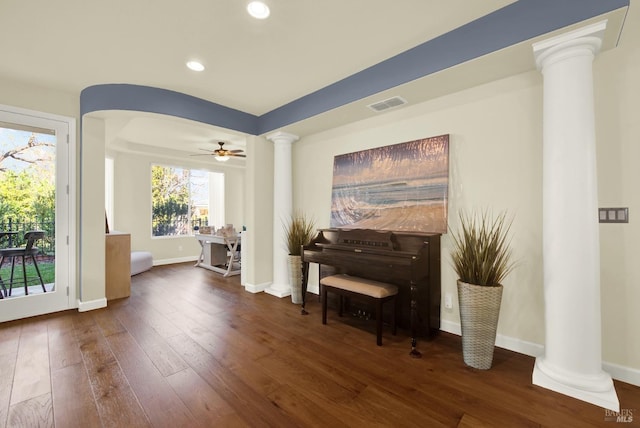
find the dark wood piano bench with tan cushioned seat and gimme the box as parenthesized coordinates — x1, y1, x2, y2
(320, 274, 398, 346)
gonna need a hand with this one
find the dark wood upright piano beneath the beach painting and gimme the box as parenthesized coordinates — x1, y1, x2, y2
(302, 228, 440, 356)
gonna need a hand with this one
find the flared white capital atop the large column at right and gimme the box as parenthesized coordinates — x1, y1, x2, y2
(532, 19, 607, 70)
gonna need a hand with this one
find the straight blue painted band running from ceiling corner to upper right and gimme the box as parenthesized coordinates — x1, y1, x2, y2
(259, 0, 629, 133)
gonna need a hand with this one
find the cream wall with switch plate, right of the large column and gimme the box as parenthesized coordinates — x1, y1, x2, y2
(594, 4, 640, 376)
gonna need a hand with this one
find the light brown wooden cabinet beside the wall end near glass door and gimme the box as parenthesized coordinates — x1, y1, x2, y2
(105, 232, 131, 300)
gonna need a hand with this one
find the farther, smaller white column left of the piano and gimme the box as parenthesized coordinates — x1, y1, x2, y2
(265, 132, 298, 297)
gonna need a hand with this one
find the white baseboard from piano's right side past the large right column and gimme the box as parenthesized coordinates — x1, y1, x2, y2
(440, 320, 640, 386)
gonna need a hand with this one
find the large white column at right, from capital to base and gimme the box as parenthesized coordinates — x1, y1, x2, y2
(533, 21, 619, 411)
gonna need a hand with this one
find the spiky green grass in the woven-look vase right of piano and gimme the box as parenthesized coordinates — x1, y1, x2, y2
(451, 211, 514, 286)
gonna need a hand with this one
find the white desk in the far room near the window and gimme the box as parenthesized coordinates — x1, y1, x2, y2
(195, 233, 241, 276)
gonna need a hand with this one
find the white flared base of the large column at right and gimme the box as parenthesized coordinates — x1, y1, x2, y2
(532, 357, 620, 412)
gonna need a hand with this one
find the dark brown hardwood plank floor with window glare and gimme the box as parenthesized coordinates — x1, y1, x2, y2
(0, 263, 640, 428)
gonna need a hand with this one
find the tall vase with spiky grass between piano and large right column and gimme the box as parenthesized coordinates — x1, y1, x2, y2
(451, 211, 514, 370)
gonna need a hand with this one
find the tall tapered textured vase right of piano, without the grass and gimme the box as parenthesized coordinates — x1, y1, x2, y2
(458, 280, 503, 370)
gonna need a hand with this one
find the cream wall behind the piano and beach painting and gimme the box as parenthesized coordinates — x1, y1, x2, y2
(294, 72, 544, 343)
